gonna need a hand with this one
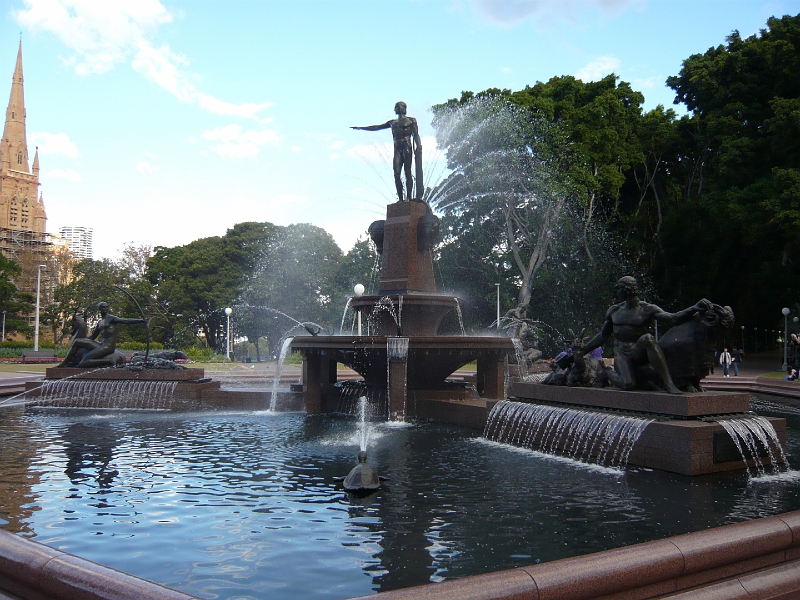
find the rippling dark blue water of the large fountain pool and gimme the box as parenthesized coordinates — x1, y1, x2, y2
(0, 398, 800, 598)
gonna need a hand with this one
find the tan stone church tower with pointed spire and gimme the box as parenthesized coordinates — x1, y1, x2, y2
(0, 41, 47, 238)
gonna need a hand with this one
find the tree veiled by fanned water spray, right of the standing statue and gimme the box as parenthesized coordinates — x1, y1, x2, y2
(430, 94, 575, 313)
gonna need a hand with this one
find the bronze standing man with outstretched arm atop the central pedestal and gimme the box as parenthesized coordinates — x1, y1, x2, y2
(351, 102, 425, 202)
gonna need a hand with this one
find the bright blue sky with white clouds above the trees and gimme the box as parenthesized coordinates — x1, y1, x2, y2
(0, 0, 800, 259)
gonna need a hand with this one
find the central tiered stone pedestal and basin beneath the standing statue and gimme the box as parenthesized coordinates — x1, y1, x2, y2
(291, 202, 514, 420)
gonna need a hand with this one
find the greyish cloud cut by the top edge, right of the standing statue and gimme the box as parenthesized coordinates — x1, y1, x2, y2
(473, 0, 642, 27)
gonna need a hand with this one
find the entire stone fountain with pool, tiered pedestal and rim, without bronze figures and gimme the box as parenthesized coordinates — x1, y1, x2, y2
(0, 103, 800, 598)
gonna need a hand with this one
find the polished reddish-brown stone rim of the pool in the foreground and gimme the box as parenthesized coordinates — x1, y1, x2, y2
(0, 511, 800, 600)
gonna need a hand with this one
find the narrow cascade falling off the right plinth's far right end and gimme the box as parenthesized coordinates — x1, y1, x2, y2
(716, 415, 789, 477)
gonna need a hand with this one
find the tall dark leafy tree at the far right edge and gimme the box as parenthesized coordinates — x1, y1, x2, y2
(660, 16, 800, 324)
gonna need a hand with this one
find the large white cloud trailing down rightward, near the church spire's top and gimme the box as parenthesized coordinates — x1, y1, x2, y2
(13, 0, 271, 122)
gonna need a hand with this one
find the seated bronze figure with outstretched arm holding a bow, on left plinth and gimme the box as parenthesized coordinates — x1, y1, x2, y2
(59, 302, 147, 368)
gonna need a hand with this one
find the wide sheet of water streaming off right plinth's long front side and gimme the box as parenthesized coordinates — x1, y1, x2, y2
(483, 400, 655, 468)
